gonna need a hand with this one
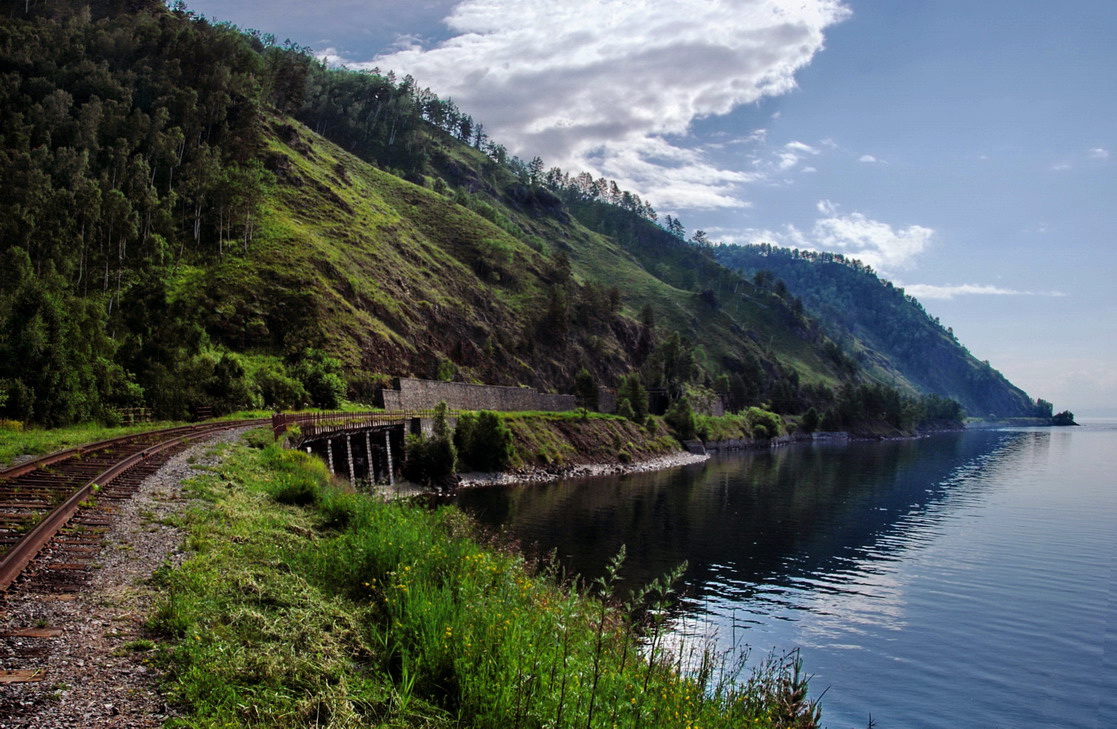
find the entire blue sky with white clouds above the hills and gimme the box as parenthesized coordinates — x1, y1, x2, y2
(189, 0, 1117, 414)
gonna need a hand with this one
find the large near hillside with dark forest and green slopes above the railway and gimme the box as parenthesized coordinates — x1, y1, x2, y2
(0, 0, 1032, 424)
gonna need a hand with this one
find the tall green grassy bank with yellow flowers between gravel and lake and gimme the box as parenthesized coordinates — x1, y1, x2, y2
(156, 435, 814, 729)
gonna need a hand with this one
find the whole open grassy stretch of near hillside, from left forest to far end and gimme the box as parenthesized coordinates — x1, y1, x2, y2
(174, 118, 837, 391)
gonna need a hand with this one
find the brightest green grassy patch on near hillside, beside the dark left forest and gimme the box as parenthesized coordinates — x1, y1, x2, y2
(175, 116, 554, 381)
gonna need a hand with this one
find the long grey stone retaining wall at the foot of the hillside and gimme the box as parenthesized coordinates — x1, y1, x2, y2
(376, 377, 577, 412)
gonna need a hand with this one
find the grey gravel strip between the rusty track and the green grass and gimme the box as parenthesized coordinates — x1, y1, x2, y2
(0, 431, 242, 729)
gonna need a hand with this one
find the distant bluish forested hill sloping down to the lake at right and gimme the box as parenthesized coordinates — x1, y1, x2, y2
(716, 244, 1036, 418)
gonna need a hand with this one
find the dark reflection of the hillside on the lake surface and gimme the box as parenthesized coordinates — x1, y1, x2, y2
(458, 432, 1023, 612)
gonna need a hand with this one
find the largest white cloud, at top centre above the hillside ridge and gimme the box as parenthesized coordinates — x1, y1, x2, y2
(357, 0, 849, 208)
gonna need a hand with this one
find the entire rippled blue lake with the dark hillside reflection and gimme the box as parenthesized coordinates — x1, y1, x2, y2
(458, 421, 1117, 729)
